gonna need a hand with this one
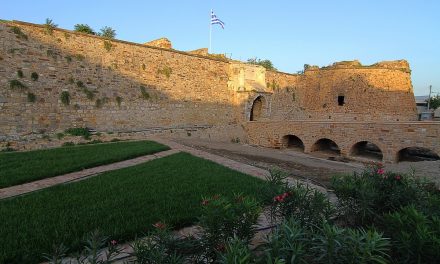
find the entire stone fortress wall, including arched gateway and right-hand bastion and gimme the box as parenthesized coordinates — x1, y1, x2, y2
(0, 21, 440, 161)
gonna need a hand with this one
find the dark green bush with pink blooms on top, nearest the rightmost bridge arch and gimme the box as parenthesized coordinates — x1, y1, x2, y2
(332, 164, 440, 226)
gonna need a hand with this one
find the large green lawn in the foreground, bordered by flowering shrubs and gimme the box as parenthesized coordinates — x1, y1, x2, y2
(0, 153, 265, 263)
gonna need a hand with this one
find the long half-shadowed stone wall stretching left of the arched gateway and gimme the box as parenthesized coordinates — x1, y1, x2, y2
(0, 22, 239, 140)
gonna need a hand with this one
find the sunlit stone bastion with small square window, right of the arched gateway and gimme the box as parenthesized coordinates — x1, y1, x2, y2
(266, 61, 417, 121)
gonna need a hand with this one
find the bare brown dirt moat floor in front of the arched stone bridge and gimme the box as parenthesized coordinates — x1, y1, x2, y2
(176, 138, 440, 187)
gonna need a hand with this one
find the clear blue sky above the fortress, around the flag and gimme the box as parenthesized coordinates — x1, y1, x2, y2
(0, 0, 440, 95)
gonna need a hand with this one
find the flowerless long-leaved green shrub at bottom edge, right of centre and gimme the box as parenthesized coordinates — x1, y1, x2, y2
(260, 218, 390, 264)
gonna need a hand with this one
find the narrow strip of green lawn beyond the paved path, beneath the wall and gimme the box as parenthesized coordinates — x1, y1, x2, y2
(0, 141, 169, 188)
